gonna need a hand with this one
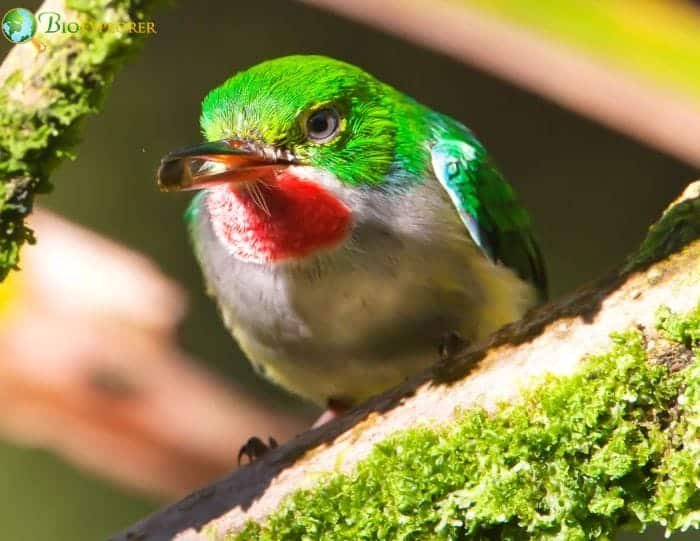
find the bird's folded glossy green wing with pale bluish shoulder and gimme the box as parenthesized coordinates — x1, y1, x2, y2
(430, 137, 547, 300)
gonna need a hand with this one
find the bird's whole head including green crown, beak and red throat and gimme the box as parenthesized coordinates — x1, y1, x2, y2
(158, 56, 429, 261)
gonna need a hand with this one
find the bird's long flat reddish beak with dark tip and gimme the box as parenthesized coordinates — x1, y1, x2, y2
(156, 139, 294, 192)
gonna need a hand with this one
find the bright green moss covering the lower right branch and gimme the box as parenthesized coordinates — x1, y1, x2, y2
(228, 308, 700, 541)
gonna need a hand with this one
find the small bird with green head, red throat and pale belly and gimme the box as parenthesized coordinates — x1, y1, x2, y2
(158, 56, 546, 405)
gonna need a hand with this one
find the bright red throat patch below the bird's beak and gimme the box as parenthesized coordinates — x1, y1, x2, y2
(207, 171, 350, 263)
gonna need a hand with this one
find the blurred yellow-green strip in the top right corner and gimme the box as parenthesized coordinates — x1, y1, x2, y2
(464, 0, 700, 99)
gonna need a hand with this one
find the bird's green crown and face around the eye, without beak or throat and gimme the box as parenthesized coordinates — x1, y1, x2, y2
(162, 55, 427, 192)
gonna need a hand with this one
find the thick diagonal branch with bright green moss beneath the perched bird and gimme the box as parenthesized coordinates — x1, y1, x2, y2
(114, 182, 700, 541)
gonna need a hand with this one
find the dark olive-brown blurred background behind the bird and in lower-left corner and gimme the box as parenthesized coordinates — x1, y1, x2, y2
(0, 0, 699, 541)
